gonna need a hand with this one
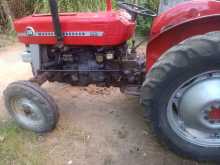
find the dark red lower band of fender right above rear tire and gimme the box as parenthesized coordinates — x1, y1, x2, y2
(146, 13, 220, 70)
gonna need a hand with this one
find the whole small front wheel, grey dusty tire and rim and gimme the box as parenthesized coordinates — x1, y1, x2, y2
(4, 81, 59, 133)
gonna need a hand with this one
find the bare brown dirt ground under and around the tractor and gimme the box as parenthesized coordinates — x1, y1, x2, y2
(0, 43, 217, 165)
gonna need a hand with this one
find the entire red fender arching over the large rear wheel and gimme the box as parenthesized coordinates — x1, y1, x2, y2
(146, 0, 220, 70)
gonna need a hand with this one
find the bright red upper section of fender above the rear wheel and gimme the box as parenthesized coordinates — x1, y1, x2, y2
(151, 0, 220, 39)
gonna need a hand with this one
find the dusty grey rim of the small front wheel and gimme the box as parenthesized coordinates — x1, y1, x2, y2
(10, 97, 44, 127)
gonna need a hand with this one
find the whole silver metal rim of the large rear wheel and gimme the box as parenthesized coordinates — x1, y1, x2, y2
(167, 71, 220, 147)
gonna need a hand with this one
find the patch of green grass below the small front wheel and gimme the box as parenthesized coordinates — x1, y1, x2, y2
(0, 122, 43, 165)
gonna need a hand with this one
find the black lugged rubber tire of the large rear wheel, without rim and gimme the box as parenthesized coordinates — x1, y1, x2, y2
(141, 32, 220, 161)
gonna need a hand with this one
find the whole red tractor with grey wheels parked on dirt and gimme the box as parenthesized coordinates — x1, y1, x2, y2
(4, 0, 220, 161)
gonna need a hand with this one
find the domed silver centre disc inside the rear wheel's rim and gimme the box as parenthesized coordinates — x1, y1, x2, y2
(179, 77, 220, 132)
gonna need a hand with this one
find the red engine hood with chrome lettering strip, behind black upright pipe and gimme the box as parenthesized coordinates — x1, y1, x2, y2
(14, 11, 135, 46)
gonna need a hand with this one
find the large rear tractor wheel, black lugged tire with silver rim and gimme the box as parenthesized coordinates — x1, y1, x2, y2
(141, 32, 220, 161)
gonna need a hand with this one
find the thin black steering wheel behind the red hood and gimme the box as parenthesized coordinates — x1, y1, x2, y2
(118, 1, 157, 17)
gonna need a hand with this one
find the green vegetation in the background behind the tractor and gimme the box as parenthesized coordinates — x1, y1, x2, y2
(0, 0, 159, 34)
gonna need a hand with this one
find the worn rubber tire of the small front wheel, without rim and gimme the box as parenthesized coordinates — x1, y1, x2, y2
(4, 81, 59, 133)
